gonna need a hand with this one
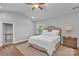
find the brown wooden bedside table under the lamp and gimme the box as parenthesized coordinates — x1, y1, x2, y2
(63, 36, 77, 49)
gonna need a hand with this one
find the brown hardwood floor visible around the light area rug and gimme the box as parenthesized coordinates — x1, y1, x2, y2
(0, 42, 79, 56)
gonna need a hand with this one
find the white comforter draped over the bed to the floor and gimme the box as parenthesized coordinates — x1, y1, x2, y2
(29, 35, 60, 55)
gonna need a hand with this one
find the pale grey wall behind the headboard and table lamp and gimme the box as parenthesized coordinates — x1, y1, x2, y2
(37, 12, 79, 47)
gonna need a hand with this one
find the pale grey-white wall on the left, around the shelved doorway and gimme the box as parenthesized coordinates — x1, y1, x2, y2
(0, 11, 35, 46)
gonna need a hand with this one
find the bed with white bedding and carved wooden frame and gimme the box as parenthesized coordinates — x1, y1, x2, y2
(28, 26, 61, 56)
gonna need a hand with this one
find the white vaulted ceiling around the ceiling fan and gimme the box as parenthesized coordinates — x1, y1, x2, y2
(0, 3, 79, 21)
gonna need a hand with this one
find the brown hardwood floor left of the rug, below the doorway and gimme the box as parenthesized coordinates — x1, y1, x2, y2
(0, 45, 23, 56)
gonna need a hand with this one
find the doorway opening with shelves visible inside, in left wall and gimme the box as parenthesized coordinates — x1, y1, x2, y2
(3, 23, 13, 45)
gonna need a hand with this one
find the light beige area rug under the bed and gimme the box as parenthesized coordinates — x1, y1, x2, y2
(15, 43, 74, 56)
